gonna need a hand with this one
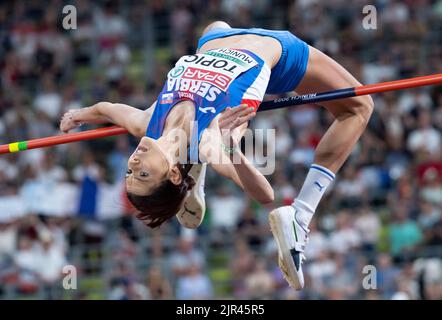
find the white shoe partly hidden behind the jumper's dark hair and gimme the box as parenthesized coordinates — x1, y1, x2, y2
(176, 163, 207, 229)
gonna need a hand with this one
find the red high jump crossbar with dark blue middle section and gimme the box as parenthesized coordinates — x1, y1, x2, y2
(0, 73, 442, 154)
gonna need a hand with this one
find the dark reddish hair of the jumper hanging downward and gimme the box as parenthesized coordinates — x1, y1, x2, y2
(126, 164, 195, 228)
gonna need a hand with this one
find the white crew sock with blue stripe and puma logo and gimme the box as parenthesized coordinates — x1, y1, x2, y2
(292, 164, 335, 228)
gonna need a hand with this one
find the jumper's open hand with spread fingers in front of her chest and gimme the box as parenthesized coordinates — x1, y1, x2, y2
(218, 104, 256, 148)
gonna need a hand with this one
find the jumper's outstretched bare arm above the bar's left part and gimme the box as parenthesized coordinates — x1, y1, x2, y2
(60, 102, 156, 137)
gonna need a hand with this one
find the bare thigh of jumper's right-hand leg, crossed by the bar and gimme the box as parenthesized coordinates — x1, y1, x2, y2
(295, 46, 361, 116)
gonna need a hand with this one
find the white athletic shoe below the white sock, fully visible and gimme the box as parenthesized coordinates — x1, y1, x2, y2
(269, 206, 309, 290)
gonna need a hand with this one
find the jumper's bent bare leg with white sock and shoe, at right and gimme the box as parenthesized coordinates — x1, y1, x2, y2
(269, 47, 373, 290)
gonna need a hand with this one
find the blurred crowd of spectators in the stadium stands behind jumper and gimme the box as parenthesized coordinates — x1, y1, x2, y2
(0, 0, 442, 299)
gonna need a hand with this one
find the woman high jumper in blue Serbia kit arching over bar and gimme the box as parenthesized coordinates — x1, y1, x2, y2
(60, 21, 373, 290)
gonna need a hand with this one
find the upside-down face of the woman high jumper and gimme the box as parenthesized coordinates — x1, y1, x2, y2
(126, 137, 171, 196)
